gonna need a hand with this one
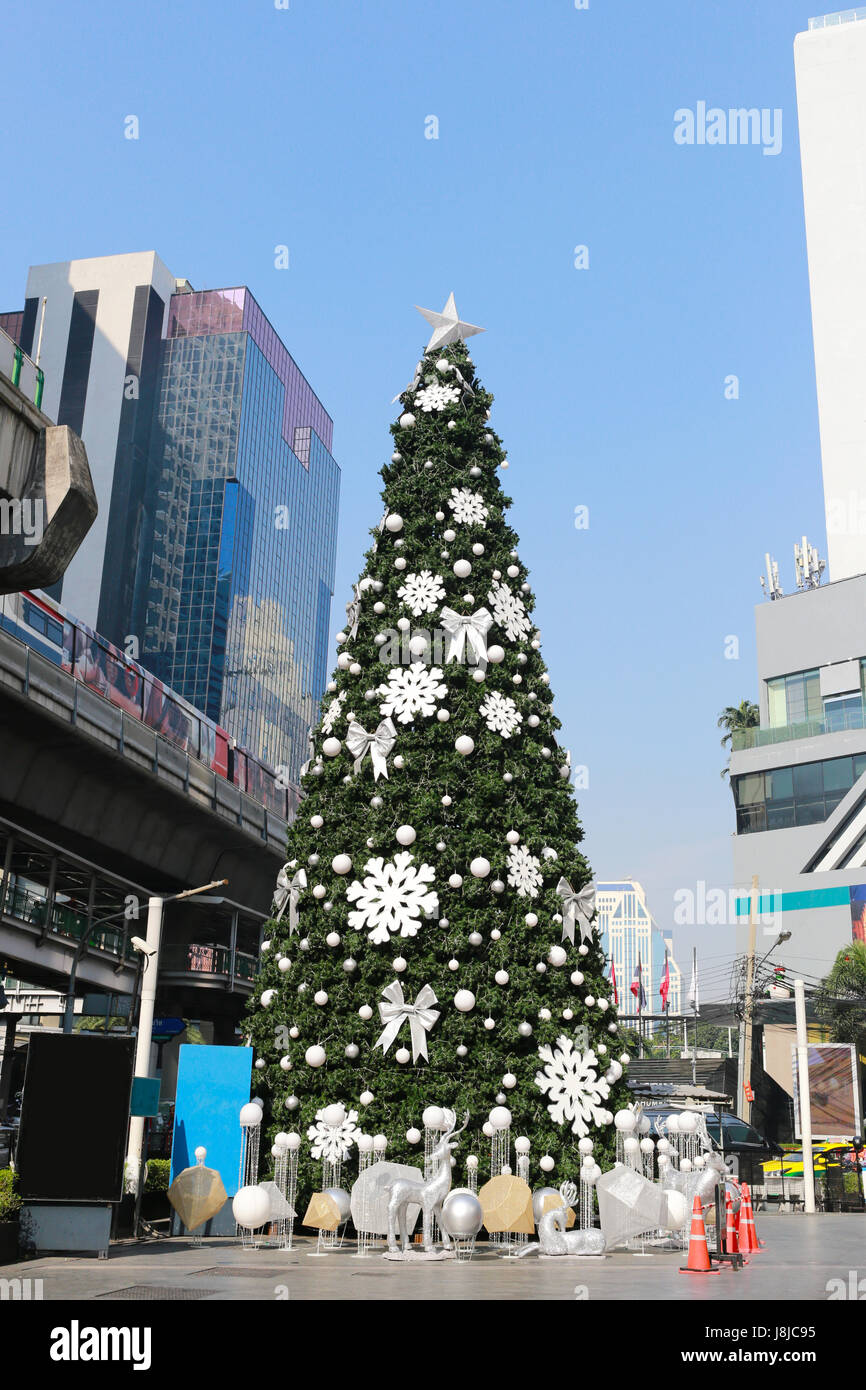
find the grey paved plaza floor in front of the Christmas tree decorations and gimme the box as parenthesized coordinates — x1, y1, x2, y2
(0, 1213, 866, 1304)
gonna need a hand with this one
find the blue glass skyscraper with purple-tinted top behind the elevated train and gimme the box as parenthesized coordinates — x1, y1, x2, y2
(135, 288, 339, 780)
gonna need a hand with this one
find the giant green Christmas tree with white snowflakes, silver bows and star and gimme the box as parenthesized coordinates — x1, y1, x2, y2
(249, 296, 628, 1182)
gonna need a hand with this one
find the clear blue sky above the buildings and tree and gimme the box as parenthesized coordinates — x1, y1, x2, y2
(0, 0, 824, 997)
